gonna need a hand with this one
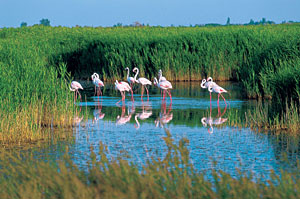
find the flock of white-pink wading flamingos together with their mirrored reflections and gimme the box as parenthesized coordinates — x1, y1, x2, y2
(70, 67, 228, 133)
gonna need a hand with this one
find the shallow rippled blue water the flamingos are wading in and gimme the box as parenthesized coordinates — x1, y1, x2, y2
(9, 82, 300, 180)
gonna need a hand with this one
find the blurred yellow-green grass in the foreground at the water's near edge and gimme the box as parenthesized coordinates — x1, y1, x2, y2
(0, 131, 300, 198)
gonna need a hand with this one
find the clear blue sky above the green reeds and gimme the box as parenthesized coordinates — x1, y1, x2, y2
(0, 0, 300, 28)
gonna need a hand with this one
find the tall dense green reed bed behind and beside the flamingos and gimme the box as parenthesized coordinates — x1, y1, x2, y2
(0, 23, 300, 142)
